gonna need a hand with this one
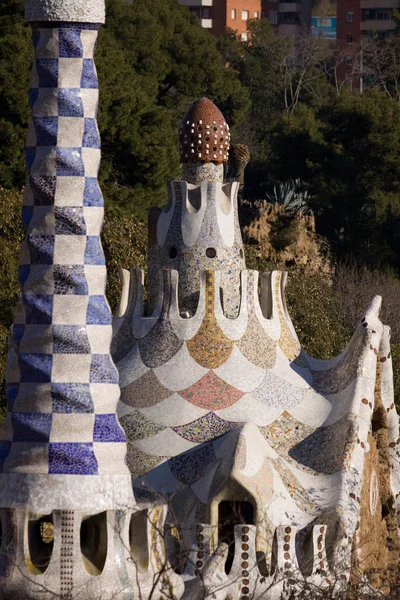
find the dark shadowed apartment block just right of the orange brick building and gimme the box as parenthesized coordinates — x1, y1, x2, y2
(262, 0, 312, 36)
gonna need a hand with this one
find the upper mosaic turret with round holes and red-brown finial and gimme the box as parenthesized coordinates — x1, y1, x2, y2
(148, 98, 246, 317)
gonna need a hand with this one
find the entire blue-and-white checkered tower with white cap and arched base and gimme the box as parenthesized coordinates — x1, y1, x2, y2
(0, 0, 133, 600)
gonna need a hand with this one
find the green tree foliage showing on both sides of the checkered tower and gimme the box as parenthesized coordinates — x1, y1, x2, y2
(0, 0, 249, 217)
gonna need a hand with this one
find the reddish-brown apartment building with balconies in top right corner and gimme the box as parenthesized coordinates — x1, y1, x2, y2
(337, 0, 400, 44)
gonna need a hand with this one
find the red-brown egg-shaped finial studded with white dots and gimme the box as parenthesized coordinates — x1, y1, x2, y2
(179, 98, 231, 164)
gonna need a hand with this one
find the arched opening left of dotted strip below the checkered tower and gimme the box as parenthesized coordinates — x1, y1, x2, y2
(25, 514, 54, 575)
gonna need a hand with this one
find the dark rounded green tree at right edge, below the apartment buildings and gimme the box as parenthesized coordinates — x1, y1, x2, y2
(269, 89, 400, 268)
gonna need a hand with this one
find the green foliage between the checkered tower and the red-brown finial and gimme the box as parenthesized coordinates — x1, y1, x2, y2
(96, 0, 248, 216)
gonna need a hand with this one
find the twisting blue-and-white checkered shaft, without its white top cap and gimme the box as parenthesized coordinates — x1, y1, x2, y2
(1, 4, 131, 510)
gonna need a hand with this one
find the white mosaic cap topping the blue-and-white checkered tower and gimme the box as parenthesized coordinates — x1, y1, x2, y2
(25, 0, 105, 24)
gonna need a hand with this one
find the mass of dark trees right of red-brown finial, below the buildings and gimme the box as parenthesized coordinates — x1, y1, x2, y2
(219, 21, 400, 272)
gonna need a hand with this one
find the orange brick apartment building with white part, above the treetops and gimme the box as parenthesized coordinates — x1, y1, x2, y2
(179, 0, 261, 40)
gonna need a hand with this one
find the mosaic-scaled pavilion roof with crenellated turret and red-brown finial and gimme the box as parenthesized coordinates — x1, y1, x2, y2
(113, 99, 400, 600)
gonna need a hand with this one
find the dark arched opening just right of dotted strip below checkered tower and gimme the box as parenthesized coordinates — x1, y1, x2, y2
(80, 512, 107, 575)
